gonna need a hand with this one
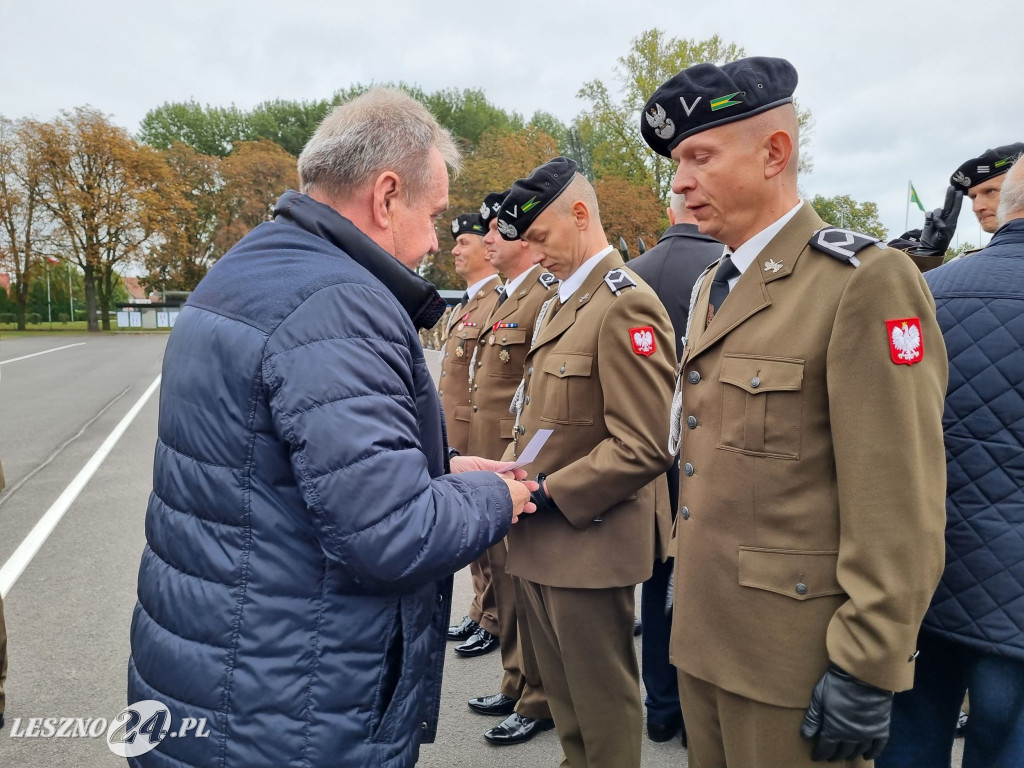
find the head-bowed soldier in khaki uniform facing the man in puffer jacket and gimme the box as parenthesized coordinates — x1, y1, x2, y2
(498, 158, 675, 768)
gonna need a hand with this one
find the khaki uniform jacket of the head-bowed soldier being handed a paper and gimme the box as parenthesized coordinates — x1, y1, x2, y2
(505, 252, 675, 588)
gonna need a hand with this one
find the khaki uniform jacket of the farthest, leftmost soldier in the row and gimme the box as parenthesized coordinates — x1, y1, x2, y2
(437, 274, 501, 454)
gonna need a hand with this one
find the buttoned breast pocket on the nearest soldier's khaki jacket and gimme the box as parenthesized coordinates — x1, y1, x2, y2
(718, 354, 804, 459)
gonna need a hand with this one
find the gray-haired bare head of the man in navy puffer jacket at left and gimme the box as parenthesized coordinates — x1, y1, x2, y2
(299, 88, 461, 268)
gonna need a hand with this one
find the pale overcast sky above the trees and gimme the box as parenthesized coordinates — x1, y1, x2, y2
(0, 0, 1024, 244)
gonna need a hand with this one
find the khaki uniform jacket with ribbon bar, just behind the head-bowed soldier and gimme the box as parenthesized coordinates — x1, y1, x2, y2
(468, 266, 558, 459)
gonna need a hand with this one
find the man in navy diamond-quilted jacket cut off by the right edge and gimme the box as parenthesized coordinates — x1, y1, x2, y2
(878, 157, 1024, 768)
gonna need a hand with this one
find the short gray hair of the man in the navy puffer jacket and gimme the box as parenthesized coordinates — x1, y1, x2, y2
(299, 88, 462, 200)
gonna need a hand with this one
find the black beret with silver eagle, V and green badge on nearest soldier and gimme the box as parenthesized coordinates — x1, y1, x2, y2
(640, 56, 797, 158)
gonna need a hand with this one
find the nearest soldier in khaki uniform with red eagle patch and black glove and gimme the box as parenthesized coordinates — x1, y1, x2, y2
(641, 57, 946, 768)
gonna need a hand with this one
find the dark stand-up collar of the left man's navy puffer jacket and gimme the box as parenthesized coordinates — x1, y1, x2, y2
(273, 189, 444, 329)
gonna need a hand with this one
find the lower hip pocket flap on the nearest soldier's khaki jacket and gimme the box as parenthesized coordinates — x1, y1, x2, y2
(739, 547, 843, 600)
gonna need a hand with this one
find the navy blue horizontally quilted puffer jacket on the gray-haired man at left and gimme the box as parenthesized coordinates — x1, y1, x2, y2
(128, 193, 512, 768)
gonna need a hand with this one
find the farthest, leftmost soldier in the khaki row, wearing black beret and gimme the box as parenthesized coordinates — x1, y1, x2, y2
(437, 213, 501, 655)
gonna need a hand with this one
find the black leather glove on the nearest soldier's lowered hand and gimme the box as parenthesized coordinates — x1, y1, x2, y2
(800, 665, 893, 762)
